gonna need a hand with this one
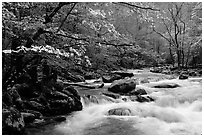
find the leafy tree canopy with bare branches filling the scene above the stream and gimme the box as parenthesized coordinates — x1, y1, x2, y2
(2, 2, 202, 68)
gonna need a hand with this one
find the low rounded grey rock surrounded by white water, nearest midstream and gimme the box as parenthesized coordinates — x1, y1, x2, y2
(108, 108, 131, 116)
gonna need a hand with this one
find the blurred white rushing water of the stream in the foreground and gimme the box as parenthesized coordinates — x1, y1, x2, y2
(26, 69, 202, 135)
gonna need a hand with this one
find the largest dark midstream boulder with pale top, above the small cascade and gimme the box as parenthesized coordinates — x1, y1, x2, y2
(108, 79, 136, 94)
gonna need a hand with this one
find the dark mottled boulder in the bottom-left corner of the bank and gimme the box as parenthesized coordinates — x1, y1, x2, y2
(2, 108, 25, 135)
